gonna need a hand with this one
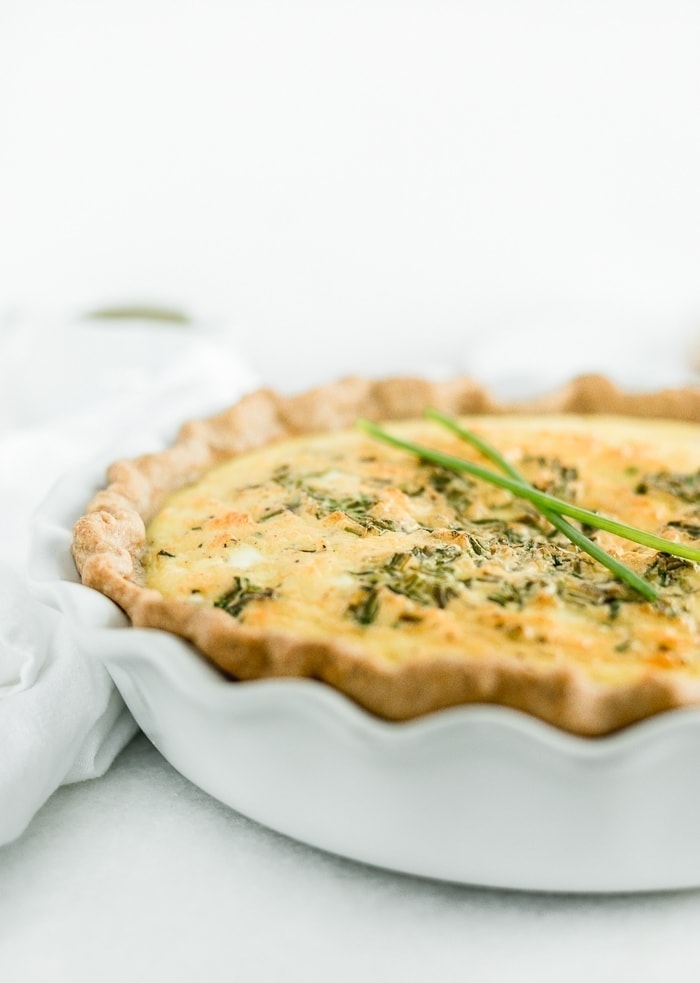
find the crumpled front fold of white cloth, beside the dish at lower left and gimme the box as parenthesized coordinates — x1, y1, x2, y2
(0, 568, 136, 842)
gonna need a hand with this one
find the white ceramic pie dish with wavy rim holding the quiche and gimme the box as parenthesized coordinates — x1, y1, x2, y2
(30, 418, 700, 892)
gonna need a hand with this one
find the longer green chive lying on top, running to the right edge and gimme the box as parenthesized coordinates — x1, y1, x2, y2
(357, 418, 700, 584)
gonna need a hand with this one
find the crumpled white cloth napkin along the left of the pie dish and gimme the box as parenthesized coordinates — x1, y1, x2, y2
(0, 322, 258, 844)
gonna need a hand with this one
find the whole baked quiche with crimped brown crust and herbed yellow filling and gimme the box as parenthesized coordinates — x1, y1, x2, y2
(73, 376, 700, 736)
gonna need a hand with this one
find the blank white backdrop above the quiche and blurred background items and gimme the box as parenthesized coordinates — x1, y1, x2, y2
(0, 0, 700, 384)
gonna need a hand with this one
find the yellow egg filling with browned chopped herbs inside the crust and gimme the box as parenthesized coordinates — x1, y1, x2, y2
(141, 415, 700, 684)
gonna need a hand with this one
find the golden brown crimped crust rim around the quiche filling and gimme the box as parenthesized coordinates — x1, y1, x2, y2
(73, 375, 700, 736)
